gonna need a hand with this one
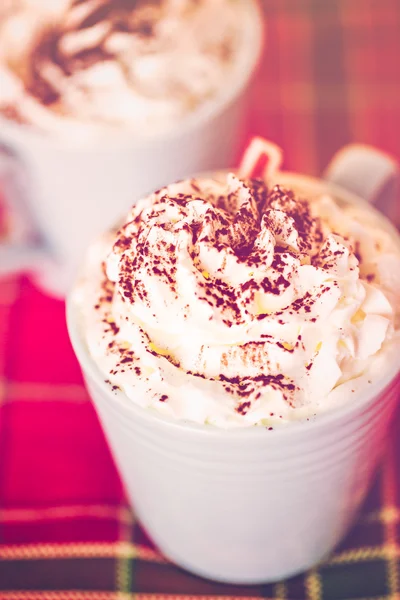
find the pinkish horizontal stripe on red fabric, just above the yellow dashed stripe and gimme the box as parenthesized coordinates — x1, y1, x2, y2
(0, 504, 132, 524)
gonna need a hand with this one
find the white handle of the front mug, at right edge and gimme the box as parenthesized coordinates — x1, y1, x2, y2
(323, 144, 400, 227)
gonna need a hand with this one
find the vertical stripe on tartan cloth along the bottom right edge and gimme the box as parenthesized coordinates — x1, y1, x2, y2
(381, 442, 400, 598)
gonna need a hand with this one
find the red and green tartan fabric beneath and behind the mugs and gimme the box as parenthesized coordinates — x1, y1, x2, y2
(0, 0, 400, 600)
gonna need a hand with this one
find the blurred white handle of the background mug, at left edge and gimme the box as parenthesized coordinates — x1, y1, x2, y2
(0, 144, 48, 276)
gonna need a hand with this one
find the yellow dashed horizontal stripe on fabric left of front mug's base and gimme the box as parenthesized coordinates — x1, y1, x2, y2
(0, 542, 168, 564)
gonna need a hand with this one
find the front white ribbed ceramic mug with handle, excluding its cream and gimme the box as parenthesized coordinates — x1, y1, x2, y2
(67, 146, 400, 583)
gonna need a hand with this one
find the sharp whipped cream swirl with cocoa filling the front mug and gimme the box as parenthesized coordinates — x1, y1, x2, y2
(76, 174, 400, 427)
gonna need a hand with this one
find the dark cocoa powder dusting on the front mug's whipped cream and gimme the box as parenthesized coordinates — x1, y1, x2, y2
(94, 173, 356, 416)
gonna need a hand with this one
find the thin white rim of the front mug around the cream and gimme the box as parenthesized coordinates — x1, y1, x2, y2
(66, 169, 400, 440)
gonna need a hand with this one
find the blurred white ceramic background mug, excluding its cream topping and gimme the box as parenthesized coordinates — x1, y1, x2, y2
(0, 0, 263, 295)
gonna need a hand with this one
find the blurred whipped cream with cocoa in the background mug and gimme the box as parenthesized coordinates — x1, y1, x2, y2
(0, 0, 250, 136)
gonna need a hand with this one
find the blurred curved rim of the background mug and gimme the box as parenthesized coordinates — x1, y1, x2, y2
(0, 0, 266, 152)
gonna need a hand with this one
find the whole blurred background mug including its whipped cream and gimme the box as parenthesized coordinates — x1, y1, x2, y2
(0, 0, 263, 296)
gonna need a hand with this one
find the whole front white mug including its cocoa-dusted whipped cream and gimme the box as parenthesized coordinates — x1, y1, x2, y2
(67, 141, 400, 583)
